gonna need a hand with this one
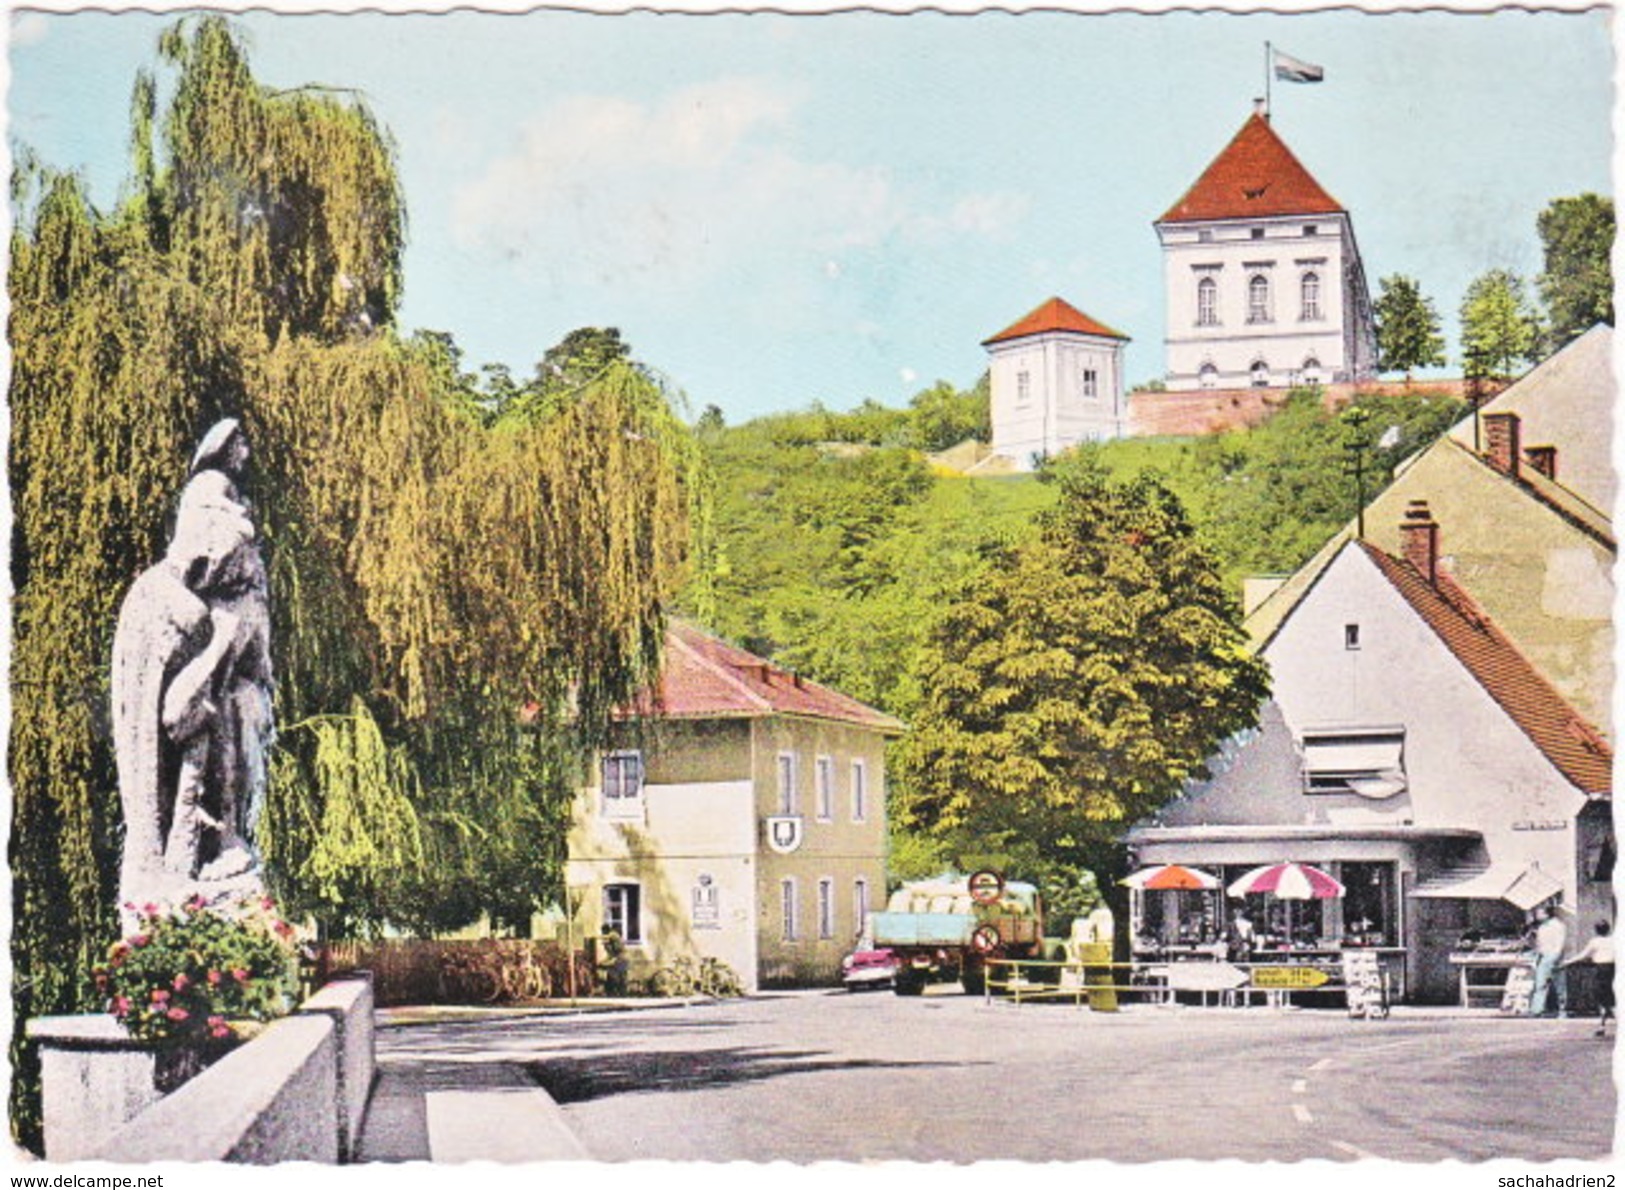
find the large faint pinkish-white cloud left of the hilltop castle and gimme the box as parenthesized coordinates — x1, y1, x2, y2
(453, 78, 1025, 286)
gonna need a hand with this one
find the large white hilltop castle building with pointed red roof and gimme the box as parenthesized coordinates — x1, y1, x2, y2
(1154, 112, 1376, 392)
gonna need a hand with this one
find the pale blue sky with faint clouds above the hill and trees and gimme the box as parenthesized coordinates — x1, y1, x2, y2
(7, 1, 1614, 423)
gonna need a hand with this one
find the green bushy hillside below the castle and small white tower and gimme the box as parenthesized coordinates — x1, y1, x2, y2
(679, 385, 1464, 719)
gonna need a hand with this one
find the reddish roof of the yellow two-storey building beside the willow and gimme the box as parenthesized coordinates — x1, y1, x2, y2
(634, 621, 904, 735)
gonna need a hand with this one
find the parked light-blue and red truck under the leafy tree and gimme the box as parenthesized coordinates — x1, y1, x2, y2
(868, 870, 1043, 997)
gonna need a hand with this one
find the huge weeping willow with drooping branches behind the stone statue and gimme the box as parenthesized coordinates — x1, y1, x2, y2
(8, 16, 704, 1146)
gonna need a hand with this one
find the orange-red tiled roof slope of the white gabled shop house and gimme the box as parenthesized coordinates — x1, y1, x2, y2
(1360, 541, 1614, 795)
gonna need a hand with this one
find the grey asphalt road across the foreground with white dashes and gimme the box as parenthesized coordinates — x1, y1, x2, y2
(368, 992, 1617, 1162)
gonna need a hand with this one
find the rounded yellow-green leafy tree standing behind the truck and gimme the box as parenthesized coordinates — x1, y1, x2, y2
(899, 452, 1268, 866)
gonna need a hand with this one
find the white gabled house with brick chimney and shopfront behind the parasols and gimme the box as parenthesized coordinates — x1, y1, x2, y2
(1128, 501, 1615, 1001)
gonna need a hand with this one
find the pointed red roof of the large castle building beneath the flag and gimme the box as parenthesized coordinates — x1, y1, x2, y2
(1157, 112, 1342, 223)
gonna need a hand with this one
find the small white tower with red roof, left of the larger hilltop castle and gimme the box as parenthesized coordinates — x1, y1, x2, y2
(982, 298, 1128, 470)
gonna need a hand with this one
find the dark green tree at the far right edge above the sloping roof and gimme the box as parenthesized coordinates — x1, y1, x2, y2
(1536, 193, 1614, 351)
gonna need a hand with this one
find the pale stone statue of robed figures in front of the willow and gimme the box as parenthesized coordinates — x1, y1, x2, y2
(112, 418, 271, 927)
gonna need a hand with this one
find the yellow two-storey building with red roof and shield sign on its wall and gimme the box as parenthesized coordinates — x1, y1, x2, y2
(566, 624, 902, 990)
